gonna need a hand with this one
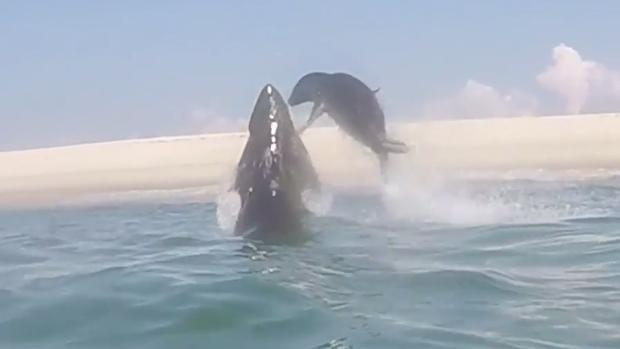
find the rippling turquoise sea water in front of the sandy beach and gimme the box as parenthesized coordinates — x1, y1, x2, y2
(0, 179, 620, 349)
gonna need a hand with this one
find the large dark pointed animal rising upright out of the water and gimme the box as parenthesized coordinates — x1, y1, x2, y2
(234, 84, 320, 238)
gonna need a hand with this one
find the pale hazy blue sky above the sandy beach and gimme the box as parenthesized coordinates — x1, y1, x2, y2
(0, 0, 620, 150)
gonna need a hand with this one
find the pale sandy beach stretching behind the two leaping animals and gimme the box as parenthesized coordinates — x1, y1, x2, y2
(0, 114, 620, 204)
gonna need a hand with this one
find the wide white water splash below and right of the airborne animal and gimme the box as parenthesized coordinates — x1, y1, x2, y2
(381, 158, 620, 225)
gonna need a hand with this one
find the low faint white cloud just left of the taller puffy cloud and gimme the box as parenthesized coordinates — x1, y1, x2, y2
(423, 80, 537, 118)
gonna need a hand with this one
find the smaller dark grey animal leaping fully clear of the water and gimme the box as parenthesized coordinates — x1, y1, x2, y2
(288, 72, 409, 178)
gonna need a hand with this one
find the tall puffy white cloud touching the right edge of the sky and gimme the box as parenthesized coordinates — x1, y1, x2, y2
(536, 44, 620, 114)
